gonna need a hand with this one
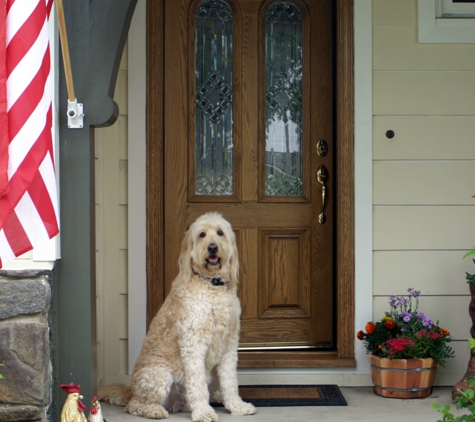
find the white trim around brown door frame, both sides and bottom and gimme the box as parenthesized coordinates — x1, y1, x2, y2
(128, 0, 373, 385)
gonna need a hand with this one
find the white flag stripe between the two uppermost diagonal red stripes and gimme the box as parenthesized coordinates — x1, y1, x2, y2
(7, 20, 48, 111)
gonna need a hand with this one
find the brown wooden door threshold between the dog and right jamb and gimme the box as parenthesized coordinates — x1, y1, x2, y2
(238, 350, 356, 368)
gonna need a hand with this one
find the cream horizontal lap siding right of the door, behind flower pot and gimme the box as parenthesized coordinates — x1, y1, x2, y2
(373, 0, 475, 384)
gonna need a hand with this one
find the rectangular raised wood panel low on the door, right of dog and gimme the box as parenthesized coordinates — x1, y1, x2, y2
(259, 229, 311, 319)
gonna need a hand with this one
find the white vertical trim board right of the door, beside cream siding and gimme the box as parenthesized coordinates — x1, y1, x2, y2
(354, 0, 373, 374)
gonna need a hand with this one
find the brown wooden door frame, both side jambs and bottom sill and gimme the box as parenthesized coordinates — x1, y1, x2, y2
(146, 0, 356, 367)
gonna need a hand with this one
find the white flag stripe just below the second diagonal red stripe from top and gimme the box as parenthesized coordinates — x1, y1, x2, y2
(8, 72, 51, 180)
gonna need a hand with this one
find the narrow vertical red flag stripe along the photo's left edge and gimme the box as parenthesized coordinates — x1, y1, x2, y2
(0, 1, 9, 195)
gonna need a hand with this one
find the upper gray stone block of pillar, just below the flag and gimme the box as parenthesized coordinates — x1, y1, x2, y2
(0, 276, 51, 319)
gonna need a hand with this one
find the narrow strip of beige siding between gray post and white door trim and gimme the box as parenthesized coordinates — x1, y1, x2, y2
(95, 41, 128, 383)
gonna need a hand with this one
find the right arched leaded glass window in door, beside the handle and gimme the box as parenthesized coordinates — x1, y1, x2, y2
(265, 1, 303, 196)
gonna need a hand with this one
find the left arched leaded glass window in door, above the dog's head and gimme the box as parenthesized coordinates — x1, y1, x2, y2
(195, 0, 234, 195)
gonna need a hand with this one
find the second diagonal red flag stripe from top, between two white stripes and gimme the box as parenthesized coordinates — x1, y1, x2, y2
(9, 48, 50, 139)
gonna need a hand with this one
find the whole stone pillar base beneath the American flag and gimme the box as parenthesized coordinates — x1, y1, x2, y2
(0, 270, 52, 422)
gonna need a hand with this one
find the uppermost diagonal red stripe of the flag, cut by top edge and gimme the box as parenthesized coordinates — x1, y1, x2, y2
(7, 1, 46, 73)
